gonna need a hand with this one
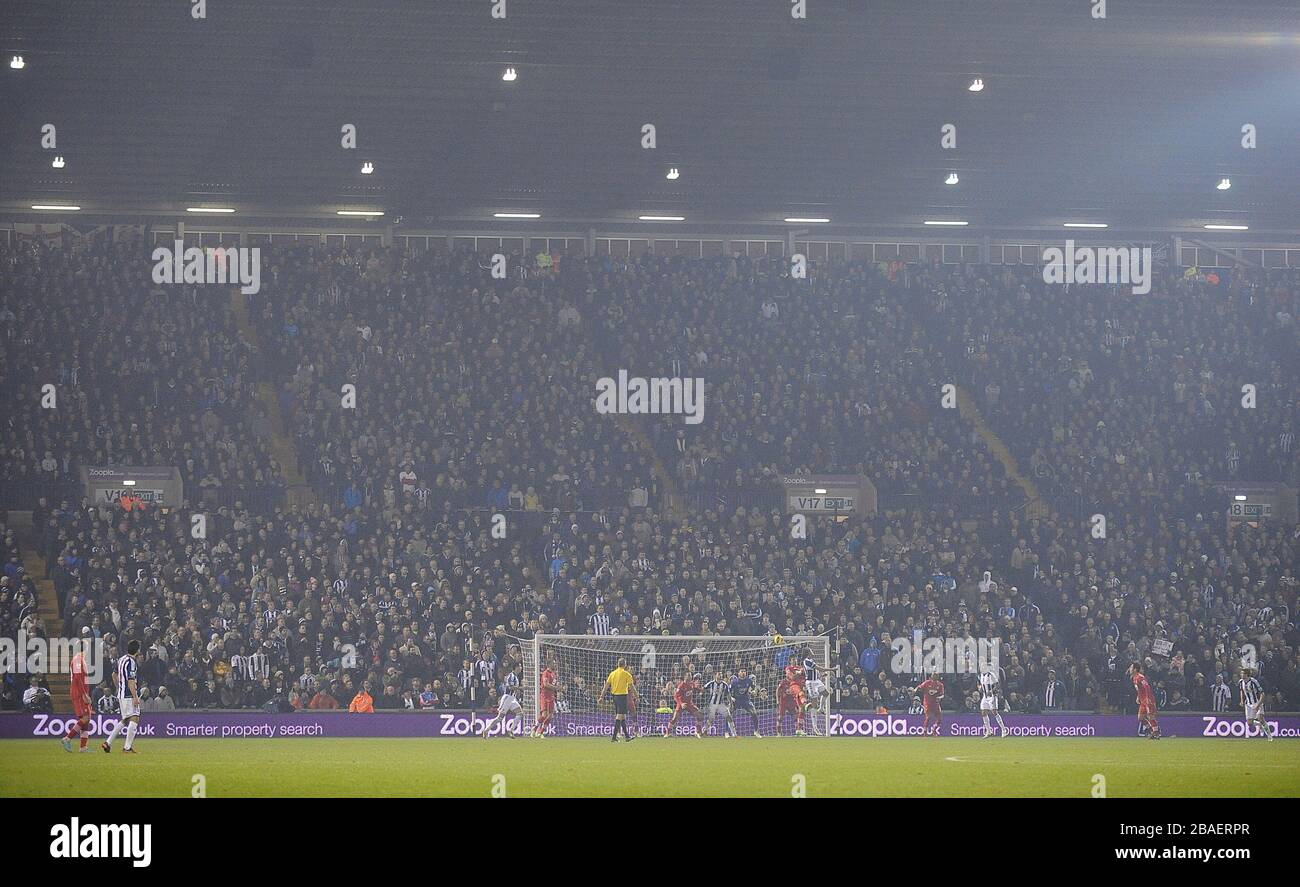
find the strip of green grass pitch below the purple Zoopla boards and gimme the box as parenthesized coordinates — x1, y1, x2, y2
(0, 737, 1300, 797)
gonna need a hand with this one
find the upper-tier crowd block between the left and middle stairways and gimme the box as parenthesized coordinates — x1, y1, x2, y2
(259, 250, 654, 511)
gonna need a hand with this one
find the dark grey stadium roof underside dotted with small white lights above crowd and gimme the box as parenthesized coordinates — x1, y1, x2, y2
(0, 0, 1300, 232)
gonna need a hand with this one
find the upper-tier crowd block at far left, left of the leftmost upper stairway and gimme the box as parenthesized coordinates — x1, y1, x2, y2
(0, 241, 283, 507)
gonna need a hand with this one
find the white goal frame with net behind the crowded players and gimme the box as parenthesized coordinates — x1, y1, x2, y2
(520, 635, 831, 736)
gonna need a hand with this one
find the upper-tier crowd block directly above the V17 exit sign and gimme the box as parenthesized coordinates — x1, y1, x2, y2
(595, 256, 1023, 516)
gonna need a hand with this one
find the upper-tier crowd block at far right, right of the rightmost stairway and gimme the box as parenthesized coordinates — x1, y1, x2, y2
(909, 258, 1300, 519)
